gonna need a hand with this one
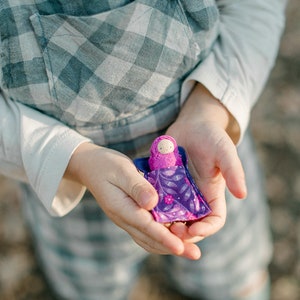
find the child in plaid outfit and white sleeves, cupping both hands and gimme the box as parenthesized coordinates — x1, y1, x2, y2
(0, 0, 285, 300)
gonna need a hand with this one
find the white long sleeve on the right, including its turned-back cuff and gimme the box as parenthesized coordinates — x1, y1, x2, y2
(182, 0, 287, 144)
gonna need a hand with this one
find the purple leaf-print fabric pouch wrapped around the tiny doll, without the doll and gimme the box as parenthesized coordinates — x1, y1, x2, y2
(134, 147, 211, 223)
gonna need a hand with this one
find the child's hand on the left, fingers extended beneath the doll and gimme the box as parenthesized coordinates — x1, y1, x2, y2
(65, 143, 200, 259)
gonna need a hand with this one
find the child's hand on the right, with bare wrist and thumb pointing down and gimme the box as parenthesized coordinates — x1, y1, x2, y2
(167, 84, 247, 243)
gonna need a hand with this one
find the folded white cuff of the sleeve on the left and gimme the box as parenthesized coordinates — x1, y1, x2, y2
(18, 104, 90, 216)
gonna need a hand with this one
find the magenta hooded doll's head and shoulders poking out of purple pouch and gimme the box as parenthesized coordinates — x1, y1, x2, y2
(149, 135, 182, 170)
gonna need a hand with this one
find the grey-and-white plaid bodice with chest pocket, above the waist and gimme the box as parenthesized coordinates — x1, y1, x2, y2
(0, 0, 218, 151)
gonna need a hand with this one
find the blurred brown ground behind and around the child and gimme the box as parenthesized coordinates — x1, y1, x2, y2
(0, 0, 300, 300)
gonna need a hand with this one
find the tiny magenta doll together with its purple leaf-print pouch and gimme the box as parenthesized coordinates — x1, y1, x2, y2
(134, 135, 211, 223)
